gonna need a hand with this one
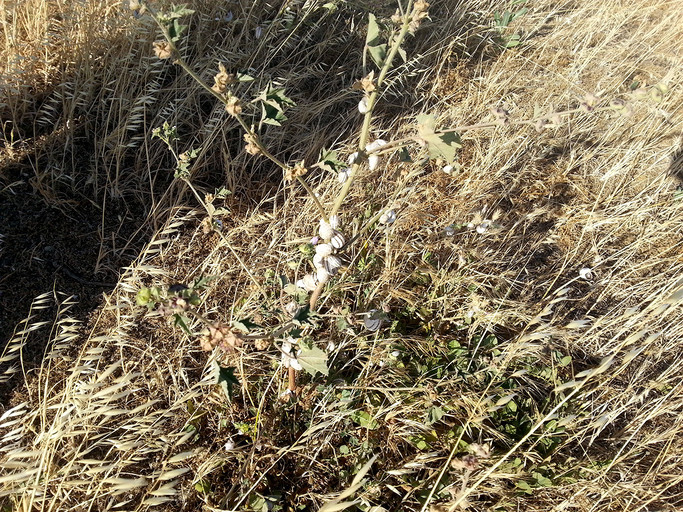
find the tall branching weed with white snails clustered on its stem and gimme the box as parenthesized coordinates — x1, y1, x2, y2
(130, 0, 667, 400)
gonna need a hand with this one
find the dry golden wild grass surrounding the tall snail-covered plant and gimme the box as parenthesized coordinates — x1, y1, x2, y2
(0, 0, 683, 512)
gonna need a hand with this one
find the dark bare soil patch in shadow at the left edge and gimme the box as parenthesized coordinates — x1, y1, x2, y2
(0, 171, 149, 403)
